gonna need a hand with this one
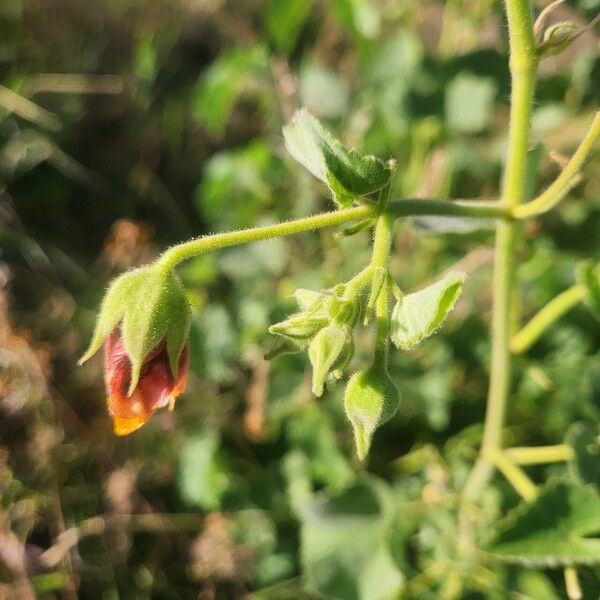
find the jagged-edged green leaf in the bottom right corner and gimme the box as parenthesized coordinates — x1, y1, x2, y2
(487, 481, 600, 567)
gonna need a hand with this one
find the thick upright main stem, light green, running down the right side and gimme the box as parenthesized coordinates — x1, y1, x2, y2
(464, 0, 537, 501)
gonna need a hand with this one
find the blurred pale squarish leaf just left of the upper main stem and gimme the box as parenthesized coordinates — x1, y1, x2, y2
(445, 73, 497, 133)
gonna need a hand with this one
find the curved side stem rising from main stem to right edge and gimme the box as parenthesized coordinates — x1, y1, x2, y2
(513, 112, 600, 219)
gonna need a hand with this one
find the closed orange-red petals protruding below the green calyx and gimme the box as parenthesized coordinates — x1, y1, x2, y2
(104, 327, 189, 435)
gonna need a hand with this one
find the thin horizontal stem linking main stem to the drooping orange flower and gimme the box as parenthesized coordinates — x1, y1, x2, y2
(159, 199, 512, 269)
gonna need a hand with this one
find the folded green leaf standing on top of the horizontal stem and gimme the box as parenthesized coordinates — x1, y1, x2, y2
(283, 109, 392, 206)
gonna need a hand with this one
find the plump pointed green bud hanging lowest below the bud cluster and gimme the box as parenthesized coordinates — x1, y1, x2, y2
(344, 365, 400, 460)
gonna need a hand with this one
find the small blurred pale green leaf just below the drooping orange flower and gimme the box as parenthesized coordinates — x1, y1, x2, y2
(177, 429, 228, 511)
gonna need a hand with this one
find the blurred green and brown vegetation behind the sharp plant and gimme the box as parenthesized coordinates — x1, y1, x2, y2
(0, 0, 600, 600)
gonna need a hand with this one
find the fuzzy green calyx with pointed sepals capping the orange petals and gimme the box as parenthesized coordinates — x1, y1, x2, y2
(79, 264, 191, 395)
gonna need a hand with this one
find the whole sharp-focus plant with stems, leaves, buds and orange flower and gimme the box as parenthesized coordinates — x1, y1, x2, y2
(81, 0, 600, 597)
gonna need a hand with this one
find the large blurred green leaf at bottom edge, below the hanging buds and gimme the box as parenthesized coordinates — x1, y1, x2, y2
(301, 481, 404, 600)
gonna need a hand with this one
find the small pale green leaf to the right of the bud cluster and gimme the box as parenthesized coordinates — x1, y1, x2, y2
(390, 271, 467, 350)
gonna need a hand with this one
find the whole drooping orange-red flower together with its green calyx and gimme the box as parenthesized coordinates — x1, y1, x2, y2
(79, 264, 191, 434)
